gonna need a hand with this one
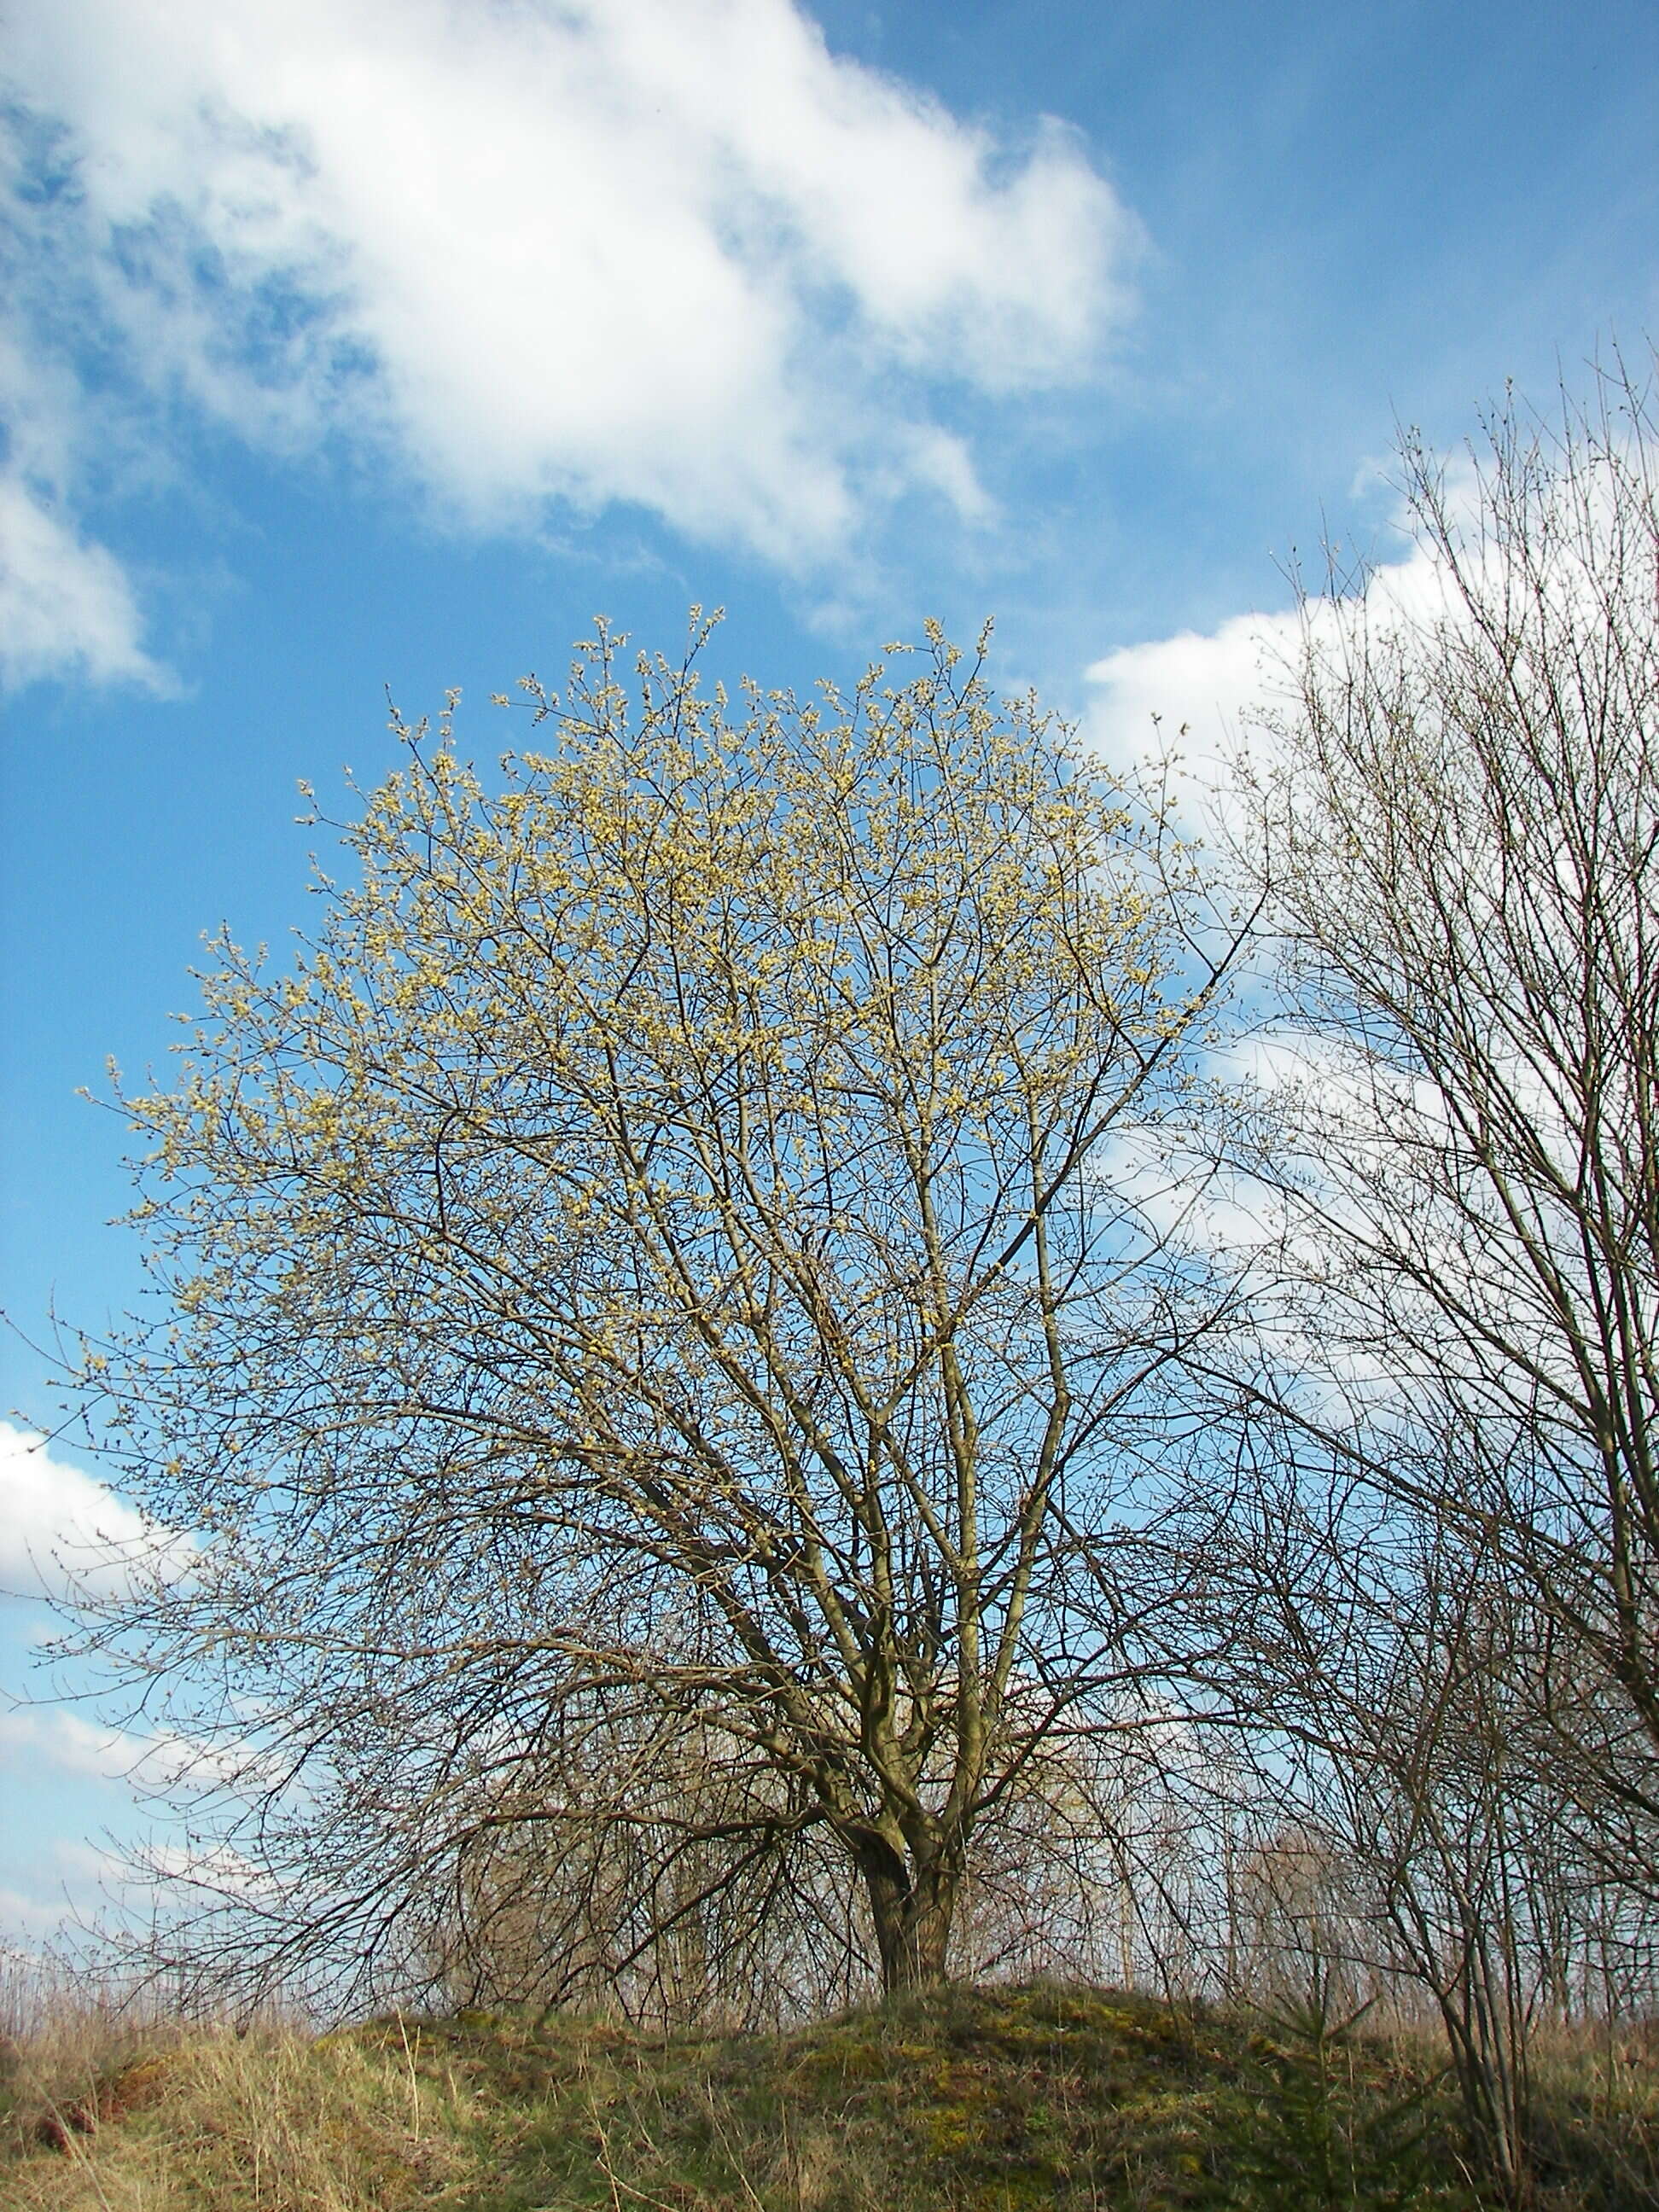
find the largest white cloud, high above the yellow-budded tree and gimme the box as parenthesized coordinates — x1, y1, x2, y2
(7, 0, 1137, 672)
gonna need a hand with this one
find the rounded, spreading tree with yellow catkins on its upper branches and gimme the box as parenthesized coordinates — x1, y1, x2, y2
(89, 631, 1225, 1988)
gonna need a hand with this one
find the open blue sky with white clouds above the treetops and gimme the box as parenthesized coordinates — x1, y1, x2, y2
(0, 0, 1659, 1938)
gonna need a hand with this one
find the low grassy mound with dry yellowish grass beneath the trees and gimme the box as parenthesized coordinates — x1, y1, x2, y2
(0, 1987, 1659, 2212)
